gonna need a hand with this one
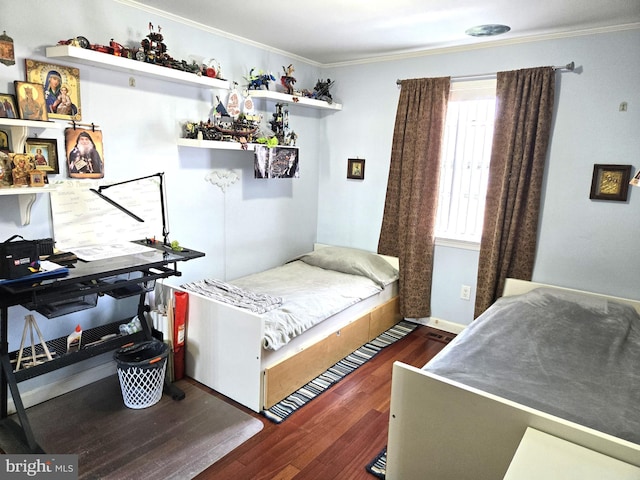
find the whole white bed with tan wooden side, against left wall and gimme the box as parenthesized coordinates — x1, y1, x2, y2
(164, 244, 401, 412)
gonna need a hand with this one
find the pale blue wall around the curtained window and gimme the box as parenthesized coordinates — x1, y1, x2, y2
(318, 28, 640, 324)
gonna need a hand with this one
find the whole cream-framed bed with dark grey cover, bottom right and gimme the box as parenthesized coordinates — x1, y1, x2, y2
(386, 279, 640, 480)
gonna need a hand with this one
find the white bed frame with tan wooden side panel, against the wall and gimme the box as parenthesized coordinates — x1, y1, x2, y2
(163, 244, 401, 412)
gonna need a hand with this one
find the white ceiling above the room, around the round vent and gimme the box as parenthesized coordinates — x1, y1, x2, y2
(127, 0, 640, 65)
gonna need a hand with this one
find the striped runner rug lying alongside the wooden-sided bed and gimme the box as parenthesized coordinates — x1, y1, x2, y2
(262, 320, 418, 423)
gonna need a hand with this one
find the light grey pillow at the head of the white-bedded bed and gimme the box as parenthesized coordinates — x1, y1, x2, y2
(296, 247, 398, 287)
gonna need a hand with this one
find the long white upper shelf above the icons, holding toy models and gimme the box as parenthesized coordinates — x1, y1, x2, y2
(47, 45, 229, 90)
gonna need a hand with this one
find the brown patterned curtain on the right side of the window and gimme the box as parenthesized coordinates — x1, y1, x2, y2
(475, 67, 555, 317)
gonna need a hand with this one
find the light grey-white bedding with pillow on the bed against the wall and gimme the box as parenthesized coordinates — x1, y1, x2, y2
(182, 247, 398, 350)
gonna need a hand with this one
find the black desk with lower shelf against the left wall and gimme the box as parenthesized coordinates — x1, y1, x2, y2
(0, 241, 204, 452)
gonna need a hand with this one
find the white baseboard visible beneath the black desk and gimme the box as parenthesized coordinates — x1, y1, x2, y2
(7, 362, 116, 414)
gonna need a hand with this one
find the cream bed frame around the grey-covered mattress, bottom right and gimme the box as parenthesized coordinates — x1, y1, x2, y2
(386, 279, 640, 480)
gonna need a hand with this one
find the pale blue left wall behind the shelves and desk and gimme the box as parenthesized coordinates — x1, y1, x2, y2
(0, 0, 324, 404)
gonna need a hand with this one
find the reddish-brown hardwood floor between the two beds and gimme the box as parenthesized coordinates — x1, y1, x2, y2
(194, 326, 451, 480)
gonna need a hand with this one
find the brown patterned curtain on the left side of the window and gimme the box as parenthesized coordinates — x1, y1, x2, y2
(378, 77, 450, 318)
